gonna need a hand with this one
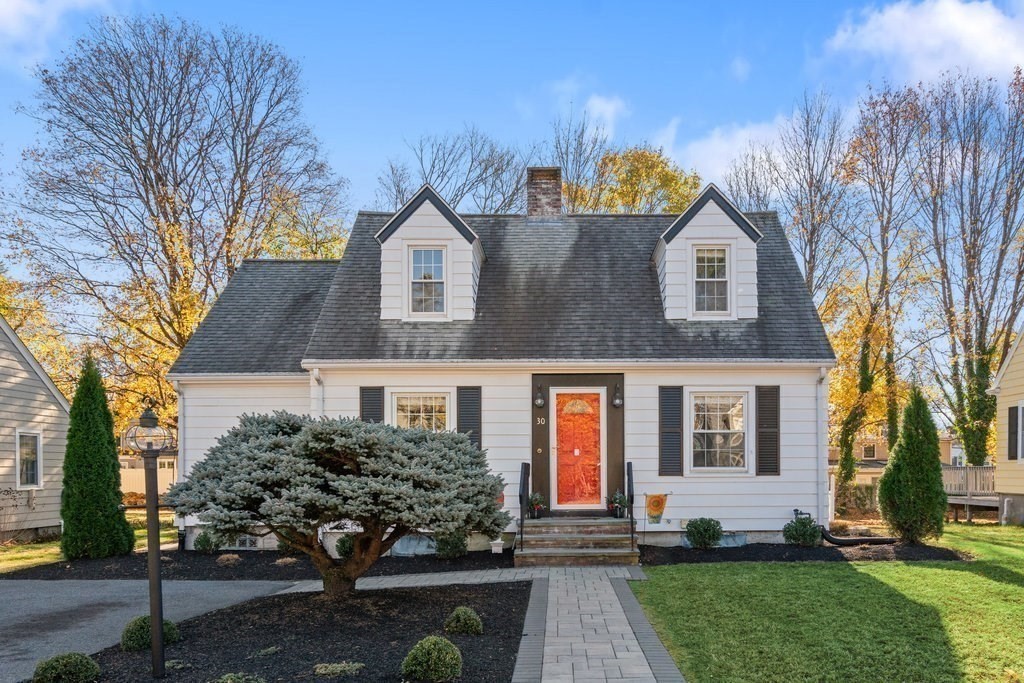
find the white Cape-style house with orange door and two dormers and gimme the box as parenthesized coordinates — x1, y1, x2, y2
(171, 168, 835, 543)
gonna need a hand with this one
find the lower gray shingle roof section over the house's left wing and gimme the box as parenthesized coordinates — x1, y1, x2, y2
(171, 260, 338, 374)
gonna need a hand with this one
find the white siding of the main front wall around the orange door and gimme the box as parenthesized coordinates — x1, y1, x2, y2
(322, 365, 827, 531)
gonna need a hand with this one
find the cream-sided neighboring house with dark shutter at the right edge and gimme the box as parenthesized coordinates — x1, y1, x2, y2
(989, 334, 1024, 524)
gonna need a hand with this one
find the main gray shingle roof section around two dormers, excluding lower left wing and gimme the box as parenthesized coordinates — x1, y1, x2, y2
(305, 212, 834, 360)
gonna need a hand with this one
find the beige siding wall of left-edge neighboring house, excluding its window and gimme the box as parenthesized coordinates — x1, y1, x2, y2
(0, 334, 68, 531)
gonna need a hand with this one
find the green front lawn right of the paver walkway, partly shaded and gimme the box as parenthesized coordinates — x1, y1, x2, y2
(633, 524, 1024, 683)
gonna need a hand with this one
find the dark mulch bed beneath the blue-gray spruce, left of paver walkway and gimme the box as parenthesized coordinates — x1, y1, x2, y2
(95, 582, 530, 683)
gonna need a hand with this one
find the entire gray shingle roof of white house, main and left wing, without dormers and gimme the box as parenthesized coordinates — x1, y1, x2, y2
(172, 212, 835, 374)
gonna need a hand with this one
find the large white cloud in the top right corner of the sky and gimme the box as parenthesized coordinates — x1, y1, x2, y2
(826, 0, 1024, 81)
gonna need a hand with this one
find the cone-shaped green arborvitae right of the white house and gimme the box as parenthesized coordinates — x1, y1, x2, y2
(879, 386, 946, 543)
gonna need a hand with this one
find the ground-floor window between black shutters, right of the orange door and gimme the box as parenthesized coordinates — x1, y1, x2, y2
(690, 393, 746, 469)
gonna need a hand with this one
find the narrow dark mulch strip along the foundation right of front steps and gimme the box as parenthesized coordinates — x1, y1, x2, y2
(640, 543, 970, 566)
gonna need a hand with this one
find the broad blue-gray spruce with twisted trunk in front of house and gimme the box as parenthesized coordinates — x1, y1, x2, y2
(167, 413, 510, 597)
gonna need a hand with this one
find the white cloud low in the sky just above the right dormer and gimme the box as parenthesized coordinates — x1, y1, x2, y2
(652, 115, 785, 183)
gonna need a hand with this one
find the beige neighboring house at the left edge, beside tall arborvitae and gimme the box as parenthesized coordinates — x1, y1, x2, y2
(0, 317, 70, 541)
